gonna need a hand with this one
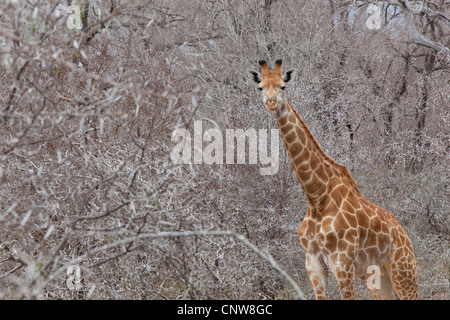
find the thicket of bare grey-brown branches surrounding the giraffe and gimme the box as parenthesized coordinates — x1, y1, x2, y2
(0, 0, 450, 299)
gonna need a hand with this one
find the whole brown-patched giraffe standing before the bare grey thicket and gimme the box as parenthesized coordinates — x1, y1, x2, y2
(249, 60, 418, 300)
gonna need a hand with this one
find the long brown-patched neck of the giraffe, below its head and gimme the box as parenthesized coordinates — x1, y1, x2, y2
(274, 99, 344, 206)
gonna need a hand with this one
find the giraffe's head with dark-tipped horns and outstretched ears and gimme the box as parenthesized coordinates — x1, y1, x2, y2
(249, 59, 295, 110)
